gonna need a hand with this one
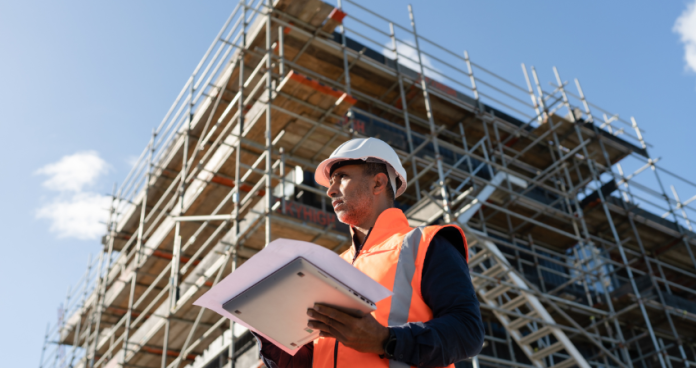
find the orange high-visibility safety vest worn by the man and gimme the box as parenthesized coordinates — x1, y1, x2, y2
(313, 208, 469, 368)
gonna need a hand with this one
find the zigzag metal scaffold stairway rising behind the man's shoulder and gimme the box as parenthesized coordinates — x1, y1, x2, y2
(406, 172, 590, 368)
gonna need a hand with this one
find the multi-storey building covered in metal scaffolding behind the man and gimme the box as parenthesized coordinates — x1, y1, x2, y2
(40, 0, 696, 368)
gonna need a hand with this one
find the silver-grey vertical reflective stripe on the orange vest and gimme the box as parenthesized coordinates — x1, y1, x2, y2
(387, 227, 423, 368)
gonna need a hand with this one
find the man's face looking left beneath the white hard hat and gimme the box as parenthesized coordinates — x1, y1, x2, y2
(326, 165, 374, 226)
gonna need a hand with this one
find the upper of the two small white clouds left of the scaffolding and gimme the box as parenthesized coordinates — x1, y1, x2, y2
(36, 151, 109, 192)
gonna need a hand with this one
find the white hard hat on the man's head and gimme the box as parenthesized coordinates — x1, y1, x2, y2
(314, 138, 406, 198)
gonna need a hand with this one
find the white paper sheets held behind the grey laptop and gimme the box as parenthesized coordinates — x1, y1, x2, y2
(193, 239, 392, 355)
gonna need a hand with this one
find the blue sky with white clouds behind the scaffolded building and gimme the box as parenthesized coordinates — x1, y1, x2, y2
(0, 0, 696, 366)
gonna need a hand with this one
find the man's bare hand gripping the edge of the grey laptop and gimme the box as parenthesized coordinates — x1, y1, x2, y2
(307, 304, 389, 354)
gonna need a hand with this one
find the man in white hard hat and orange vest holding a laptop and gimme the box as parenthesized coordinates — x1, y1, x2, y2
(259, 138, 484, 368)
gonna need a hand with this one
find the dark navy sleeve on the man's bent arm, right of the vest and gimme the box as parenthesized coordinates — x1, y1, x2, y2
(389, 233, 484, 367)
